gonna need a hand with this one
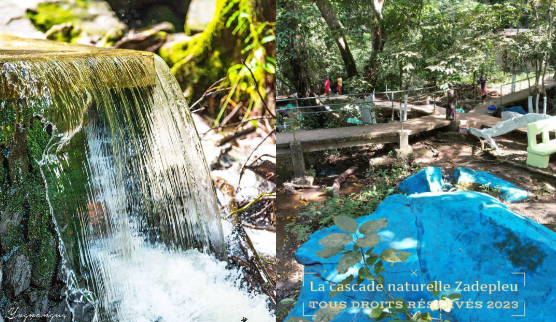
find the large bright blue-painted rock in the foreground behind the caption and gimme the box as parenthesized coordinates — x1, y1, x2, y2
(286, 191, 556, 322)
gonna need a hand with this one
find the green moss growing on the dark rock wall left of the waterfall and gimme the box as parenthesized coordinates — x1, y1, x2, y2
(0, 109, 58, 288)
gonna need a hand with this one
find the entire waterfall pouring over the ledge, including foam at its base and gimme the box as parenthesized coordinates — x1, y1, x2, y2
(0, 37, 274, 322)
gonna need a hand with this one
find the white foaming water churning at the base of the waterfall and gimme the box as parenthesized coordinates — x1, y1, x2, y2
(89, 234, 276, 322)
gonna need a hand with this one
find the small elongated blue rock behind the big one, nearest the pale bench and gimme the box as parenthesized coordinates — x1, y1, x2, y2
(454, 167, 529, 202)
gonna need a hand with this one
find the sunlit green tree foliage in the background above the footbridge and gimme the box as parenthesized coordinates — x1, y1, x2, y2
(277, 0, 556, 93)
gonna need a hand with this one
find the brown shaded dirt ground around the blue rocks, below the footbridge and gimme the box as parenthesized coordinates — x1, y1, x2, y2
(277, 127, 556, 321)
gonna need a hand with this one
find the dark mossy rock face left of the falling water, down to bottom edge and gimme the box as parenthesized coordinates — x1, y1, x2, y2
(0, 118, 71, 322)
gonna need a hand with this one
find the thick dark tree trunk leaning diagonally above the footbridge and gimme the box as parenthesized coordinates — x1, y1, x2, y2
(315, 0, 357, 77)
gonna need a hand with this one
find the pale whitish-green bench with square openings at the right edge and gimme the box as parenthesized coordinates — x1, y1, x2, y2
(527, 117, 556, 168)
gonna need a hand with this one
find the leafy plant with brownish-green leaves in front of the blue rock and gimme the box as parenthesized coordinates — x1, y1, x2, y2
(286, 215, 461, 322)
